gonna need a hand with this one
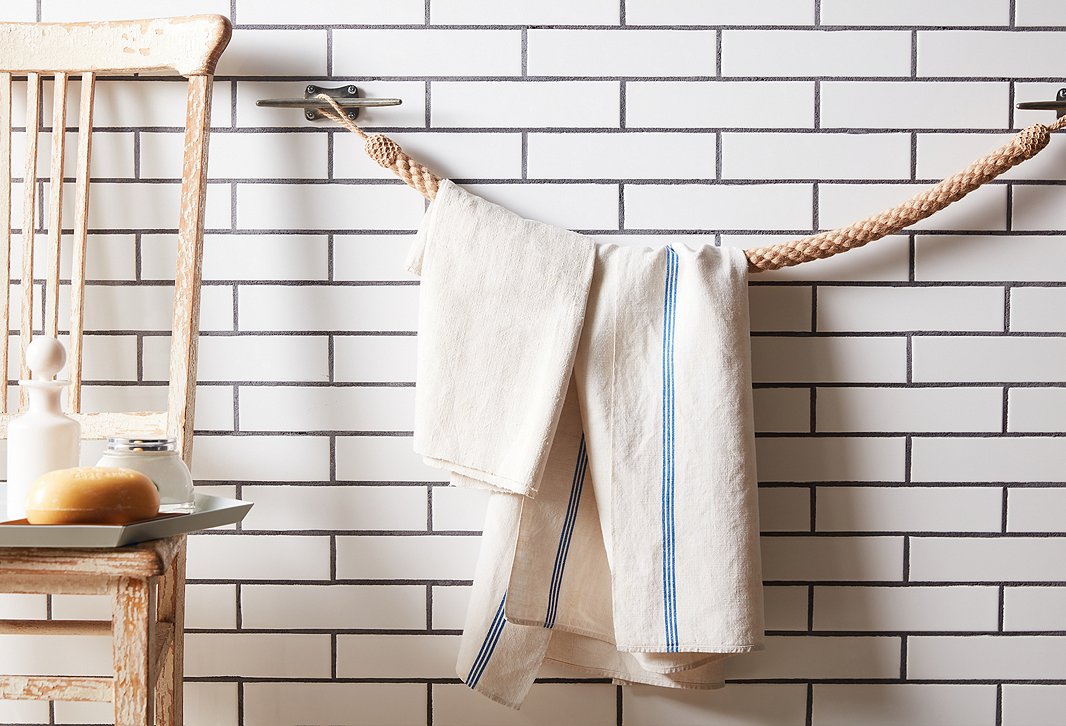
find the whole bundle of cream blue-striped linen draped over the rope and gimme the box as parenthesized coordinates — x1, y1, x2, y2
(408, 181, 763, 707)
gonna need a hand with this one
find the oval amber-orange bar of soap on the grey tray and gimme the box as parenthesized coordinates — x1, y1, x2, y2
(26, 466, 159, 525)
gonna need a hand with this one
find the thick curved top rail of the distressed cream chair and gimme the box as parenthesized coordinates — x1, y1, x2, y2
(0, 15, 232, 76)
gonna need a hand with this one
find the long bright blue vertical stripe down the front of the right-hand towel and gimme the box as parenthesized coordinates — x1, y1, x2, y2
(662, 247, 678, 652)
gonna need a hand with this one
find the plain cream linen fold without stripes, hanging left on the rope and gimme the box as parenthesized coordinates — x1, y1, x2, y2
(407, 181, 595, 495)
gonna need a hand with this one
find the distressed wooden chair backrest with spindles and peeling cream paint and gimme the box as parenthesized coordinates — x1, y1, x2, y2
(0, 15, 230, 462)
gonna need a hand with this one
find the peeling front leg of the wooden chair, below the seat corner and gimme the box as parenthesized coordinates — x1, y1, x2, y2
(112, 578, 155, 726)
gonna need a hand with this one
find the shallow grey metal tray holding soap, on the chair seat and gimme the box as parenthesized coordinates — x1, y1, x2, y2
(0, 494, 252, 545)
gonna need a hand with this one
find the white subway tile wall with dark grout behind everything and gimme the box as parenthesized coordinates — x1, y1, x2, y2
(0, 0, 1066, 726)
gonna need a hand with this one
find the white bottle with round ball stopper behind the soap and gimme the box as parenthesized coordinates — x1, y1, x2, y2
(6, 336, 81, 519)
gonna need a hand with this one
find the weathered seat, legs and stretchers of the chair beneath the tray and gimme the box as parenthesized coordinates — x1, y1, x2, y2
(0, 534, 185, 726)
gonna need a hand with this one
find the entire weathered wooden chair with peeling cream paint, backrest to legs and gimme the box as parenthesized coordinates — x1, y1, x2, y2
(0, 15, 230, 726)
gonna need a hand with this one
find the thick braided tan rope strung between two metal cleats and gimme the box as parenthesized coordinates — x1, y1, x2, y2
(318, 94, 1066, 273)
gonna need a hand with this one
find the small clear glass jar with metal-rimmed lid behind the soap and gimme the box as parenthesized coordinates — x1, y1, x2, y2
(97, 436, 194, 513)
